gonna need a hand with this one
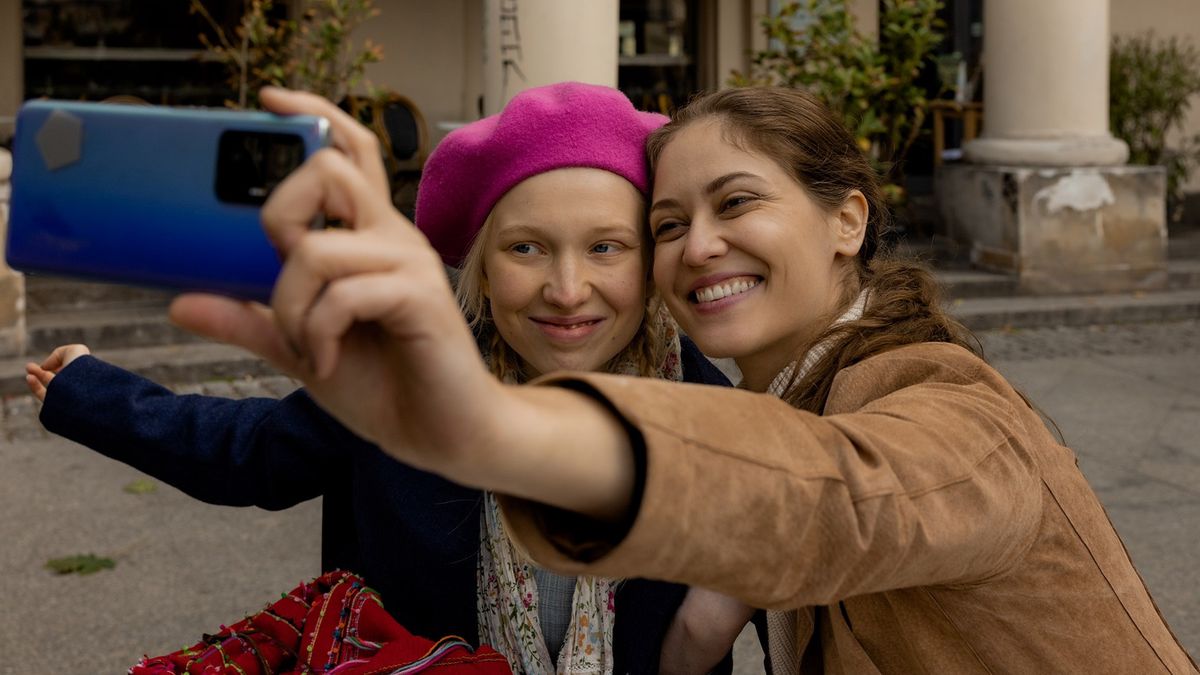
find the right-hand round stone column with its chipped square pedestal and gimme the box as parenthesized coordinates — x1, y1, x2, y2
(935, 0, 1166, 293)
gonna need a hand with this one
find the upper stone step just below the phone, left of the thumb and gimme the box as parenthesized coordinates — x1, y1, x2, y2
(25, 306, 199, 354)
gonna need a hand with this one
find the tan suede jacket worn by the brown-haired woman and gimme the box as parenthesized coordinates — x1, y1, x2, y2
(504, 344, 1196, 674)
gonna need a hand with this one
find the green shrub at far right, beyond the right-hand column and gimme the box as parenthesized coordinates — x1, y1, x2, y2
(1109, 32, 1200, 222)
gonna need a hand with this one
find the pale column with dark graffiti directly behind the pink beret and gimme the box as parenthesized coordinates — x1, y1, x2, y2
(484, 0, 620, 115)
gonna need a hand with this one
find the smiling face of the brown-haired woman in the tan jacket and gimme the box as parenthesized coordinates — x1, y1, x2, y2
(649, 120, 866, 390)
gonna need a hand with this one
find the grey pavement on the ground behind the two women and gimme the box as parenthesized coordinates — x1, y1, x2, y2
(0, 319, 1200, 675)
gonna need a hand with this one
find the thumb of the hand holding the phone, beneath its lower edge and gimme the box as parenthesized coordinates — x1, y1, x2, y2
(169, 293, 304, 377)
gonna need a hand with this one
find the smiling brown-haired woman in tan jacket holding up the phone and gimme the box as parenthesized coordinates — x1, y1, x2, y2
(174, 89, 1196, 674)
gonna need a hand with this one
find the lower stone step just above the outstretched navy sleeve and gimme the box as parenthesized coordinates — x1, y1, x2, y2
(0, 341, 278, 396)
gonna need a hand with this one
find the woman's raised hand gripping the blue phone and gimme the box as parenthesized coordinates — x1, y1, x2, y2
(172, 89, 499, 468)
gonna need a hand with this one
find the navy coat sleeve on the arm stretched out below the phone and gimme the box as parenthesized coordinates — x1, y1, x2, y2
(41, 357, 364, 509)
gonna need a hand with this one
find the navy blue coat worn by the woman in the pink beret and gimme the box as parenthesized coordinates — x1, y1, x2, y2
(41, 339, 728, 673)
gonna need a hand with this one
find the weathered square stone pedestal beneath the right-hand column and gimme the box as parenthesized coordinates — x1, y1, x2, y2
(936, 165, 1168, 294)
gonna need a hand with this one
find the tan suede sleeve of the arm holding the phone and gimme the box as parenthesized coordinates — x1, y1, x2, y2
(502, 346, 1045, 609)
